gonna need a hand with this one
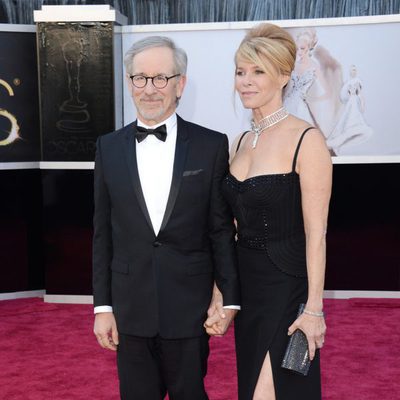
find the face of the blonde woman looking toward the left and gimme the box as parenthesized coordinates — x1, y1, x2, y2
(235, 59, 287, 115)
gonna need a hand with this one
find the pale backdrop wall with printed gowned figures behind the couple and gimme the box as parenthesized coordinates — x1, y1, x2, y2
(123, 16, 400, 158)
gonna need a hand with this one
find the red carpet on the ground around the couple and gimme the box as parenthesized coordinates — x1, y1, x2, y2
(0, 298, 400, 400)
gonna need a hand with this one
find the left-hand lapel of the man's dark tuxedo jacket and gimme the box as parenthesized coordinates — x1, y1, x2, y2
(123, 122, 154, 232)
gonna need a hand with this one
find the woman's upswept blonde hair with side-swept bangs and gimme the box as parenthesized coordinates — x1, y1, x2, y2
(235, 23, 296, 79)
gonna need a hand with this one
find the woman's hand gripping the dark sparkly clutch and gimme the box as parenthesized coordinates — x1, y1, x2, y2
(288, 313, 326, 360)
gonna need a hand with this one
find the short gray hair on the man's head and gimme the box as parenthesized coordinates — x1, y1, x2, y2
(124, 36, 187, 75)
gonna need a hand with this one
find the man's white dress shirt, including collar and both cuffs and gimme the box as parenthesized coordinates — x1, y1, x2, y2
(94, 113, 240, 314)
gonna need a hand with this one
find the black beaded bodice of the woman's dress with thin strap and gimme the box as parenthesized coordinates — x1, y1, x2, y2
(222, 132, 312, 276)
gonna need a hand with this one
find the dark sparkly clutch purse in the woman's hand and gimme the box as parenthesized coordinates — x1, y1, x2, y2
(281, 304, 311, 376)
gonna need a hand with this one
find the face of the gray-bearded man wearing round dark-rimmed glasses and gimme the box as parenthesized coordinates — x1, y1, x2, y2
(127, 47, 186, 126)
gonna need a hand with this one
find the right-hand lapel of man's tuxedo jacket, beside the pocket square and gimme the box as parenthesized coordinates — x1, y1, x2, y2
(160, 116, 189, 232)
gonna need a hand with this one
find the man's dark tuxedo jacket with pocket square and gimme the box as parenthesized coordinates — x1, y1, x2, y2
(93, 117, 240, 339)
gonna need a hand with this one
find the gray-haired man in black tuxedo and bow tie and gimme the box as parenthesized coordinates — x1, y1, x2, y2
(93, 36, 239, 400)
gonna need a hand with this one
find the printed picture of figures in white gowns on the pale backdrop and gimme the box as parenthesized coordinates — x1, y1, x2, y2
(284, 28, 373, 155)
